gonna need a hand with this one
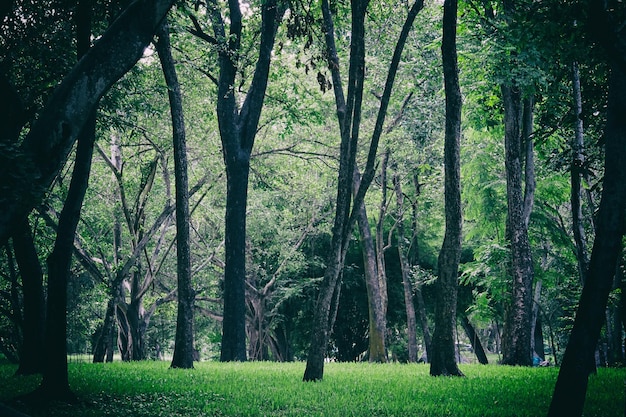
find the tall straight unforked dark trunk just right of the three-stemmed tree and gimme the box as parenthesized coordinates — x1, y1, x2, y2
(429, 0, 463, 376)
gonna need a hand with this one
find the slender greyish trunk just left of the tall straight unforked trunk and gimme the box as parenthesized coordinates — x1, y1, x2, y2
(393, 173, 416, 363)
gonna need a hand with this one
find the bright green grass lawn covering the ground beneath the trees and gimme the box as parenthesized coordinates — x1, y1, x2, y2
(0, 362, 626, 417)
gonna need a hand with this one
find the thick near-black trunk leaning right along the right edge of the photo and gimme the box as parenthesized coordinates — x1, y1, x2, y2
(548, 64, 626, 417)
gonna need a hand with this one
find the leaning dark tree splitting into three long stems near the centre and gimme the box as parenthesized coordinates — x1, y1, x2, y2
(303, 0, 423, 381)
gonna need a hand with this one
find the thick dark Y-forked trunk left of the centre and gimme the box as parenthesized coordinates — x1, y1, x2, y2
(209, 0, 285, 361)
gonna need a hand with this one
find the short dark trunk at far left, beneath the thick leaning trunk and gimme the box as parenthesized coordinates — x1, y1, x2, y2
(12, 219, 46, 375)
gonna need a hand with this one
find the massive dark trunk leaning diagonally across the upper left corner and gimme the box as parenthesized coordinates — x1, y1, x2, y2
(0, 0, 174, 241)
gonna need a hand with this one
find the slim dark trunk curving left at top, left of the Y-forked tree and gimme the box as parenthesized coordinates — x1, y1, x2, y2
(157, 23, 195, 368)
